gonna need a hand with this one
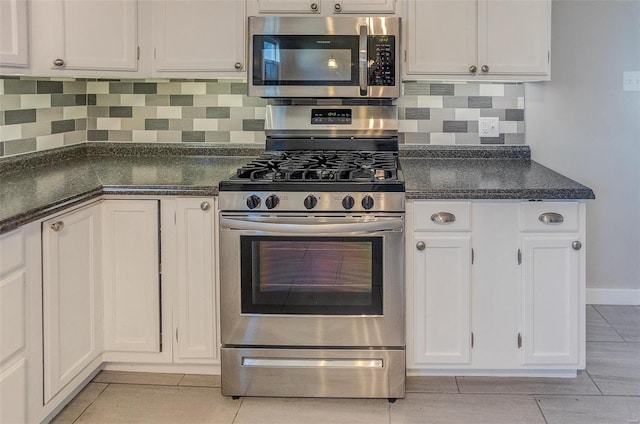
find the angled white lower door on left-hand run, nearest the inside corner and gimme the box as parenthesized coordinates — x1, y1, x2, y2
(42, 204, 102, 403)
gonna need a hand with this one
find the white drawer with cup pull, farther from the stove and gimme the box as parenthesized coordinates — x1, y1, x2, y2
(522, 202, 580, 232)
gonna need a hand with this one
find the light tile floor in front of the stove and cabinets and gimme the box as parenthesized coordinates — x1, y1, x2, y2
(54, 305, 640, 424)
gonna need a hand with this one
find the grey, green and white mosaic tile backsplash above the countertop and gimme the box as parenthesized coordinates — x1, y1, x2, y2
(0, 77, 525, 156)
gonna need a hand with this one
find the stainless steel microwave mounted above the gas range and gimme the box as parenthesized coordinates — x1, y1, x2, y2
(247, 16, 401, 98)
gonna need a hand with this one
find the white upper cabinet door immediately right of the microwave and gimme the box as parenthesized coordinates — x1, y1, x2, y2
(405, 0, 478, 75)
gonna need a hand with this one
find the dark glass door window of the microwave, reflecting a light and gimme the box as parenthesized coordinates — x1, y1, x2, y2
(253, 35, 358, 86)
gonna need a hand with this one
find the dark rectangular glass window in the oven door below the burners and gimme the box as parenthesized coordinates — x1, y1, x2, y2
(240, 236, 383, 315)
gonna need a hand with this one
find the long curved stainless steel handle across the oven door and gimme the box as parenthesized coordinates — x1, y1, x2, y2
(220, 218, 403, 234)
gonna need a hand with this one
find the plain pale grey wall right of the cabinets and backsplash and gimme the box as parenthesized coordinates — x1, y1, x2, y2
(525, 0, 640, 304)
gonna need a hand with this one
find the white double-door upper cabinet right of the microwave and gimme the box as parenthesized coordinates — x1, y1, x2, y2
(405, 0, 551, 80)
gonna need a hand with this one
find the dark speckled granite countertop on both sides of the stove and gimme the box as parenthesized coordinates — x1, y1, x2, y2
(0, 143, 594, 234)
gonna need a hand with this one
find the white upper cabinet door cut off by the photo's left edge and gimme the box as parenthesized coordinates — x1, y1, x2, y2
(0, 0, 29, 68)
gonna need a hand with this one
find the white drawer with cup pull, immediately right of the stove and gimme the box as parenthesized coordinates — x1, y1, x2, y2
(413, 202, 471, 231)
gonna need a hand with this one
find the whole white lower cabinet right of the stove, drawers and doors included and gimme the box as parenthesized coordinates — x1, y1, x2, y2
(407, 201, 585, 375)
